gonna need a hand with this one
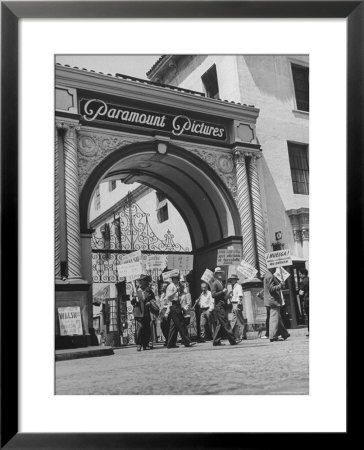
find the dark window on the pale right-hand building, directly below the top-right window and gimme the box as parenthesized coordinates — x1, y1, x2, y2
(288, 142, 309, 195)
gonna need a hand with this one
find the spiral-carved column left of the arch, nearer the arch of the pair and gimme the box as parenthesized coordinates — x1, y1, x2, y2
(63, 124, 81, 280)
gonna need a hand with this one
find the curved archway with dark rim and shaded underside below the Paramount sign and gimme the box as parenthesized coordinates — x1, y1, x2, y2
(80, 141, 245, 296)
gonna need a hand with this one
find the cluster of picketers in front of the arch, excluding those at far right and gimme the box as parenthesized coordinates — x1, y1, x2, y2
(131, 267, 246, 351)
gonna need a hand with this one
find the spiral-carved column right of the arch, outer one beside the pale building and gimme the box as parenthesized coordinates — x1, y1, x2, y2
(249, 155, 267, 275)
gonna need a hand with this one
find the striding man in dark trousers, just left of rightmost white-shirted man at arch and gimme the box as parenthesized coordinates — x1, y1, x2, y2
(211, 267, 241, 346)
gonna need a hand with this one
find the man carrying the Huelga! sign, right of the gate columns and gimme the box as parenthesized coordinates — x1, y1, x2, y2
(264, 269, 290, 342)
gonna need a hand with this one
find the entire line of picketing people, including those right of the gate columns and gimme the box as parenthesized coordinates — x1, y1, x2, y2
(131, 267, 309, 351)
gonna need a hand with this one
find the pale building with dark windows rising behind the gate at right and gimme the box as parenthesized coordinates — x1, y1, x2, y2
(147, 55, 309, 265)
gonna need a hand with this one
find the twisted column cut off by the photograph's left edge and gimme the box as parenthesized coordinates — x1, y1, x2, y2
(54, 123, 61, 280)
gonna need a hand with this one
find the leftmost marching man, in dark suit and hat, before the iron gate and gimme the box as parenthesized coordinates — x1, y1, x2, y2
(131, 274, 155, 352)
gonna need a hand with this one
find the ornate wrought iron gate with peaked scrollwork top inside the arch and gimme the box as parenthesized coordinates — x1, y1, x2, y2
(91, 192, 192, 346)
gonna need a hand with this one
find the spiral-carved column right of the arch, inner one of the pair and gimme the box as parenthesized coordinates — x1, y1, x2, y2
(234, 151, 257, 267)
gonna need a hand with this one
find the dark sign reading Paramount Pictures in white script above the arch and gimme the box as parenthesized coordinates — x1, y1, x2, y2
(80, 98, 226, 141)
